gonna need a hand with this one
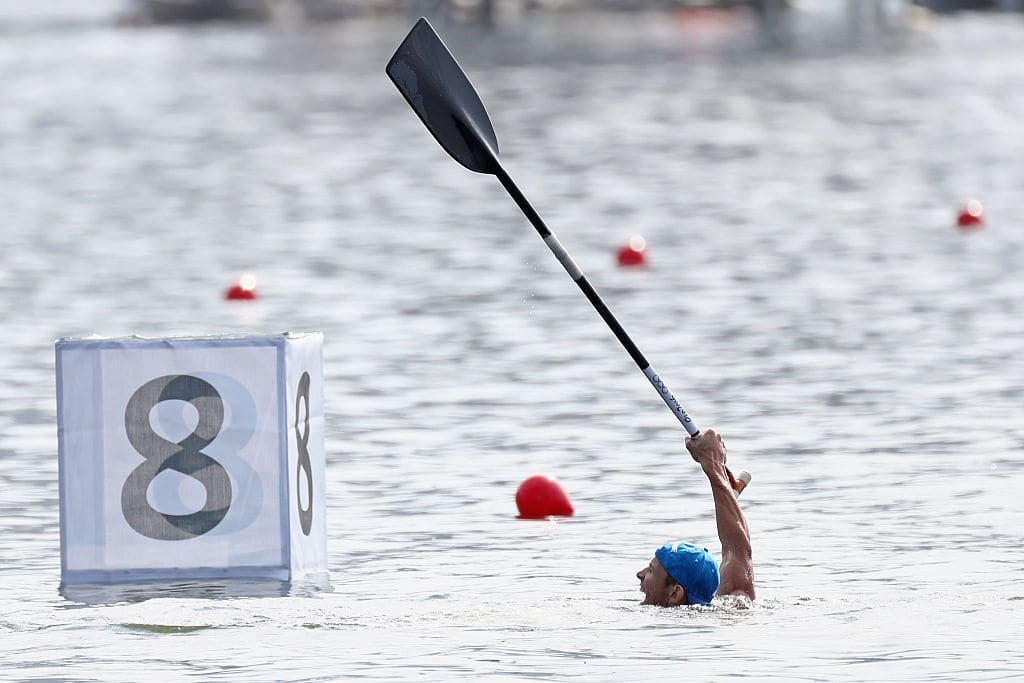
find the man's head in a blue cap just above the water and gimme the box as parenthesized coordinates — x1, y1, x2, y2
(637, 542, 719, 607)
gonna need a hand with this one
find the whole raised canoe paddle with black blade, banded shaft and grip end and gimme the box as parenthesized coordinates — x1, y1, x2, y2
(387, 18, 751, 496)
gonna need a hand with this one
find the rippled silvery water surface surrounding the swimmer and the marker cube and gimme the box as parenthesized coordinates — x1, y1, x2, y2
(0, 2, 1024, 681)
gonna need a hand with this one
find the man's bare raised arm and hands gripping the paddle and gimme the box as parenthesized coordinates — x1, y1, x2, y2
(686, 429, 754, 600)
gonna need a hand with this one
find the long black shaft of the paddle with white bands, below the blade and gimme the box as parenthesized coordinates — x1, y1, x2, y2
(495, 166, 700, 438)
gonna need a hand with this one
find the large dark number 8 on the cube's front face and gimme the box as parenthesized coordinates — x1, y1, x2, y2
(121, 375, 231, 541)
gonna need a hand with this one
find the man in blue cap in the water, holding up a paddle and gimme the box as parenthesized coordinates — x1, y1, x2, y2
(637, 429, 754, 607)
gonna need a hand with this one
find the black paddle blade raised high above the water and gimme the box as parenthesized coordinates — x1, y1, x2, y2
(387, 18, 501, 174)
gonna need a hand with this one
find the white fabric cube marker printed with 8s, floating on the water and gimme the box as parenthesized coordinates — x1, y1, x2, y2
(56, 333, 327, 584)
